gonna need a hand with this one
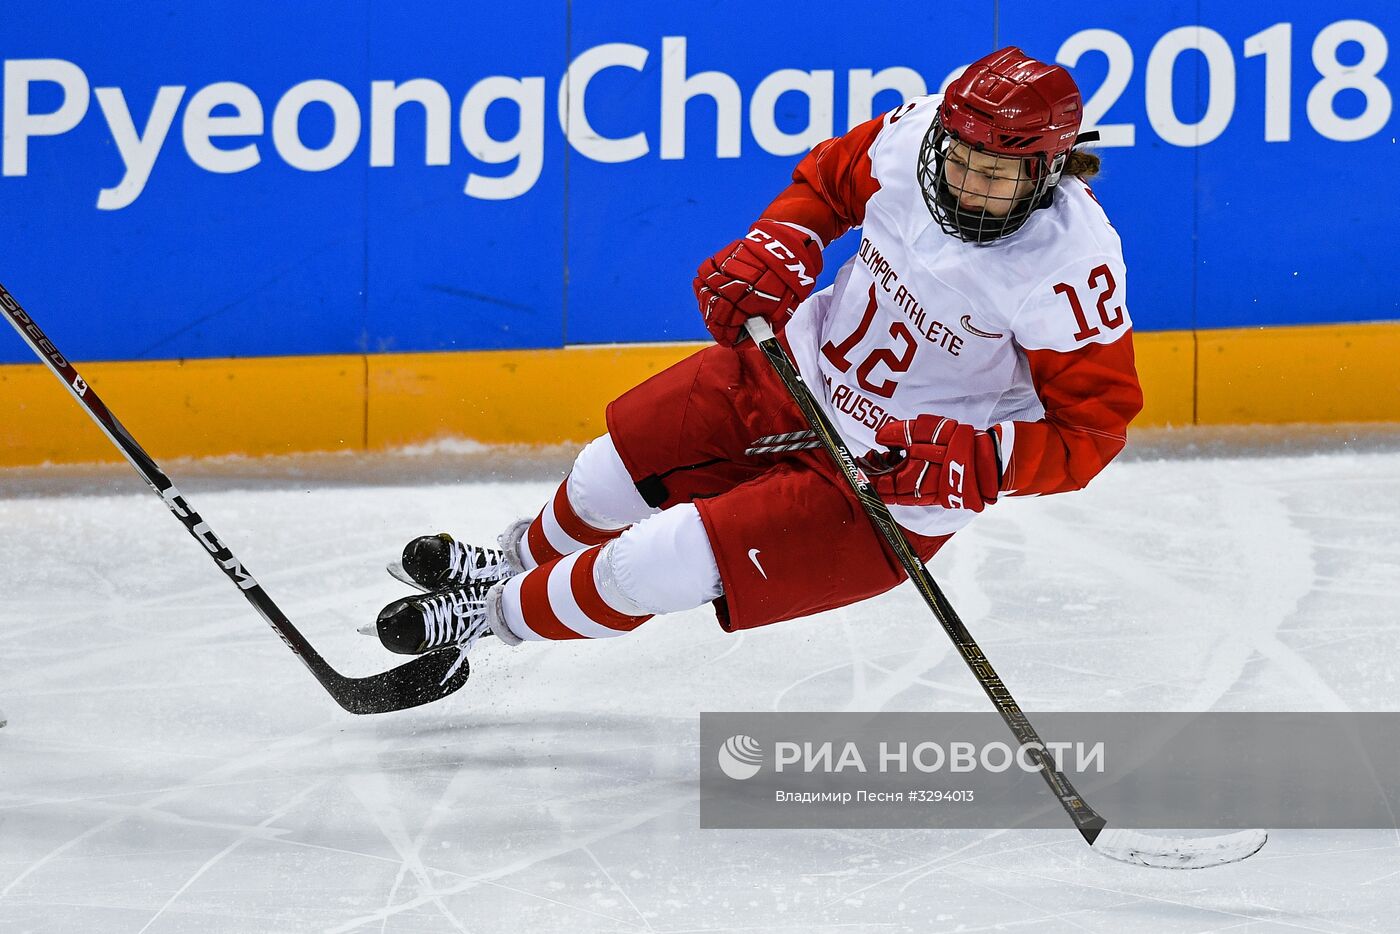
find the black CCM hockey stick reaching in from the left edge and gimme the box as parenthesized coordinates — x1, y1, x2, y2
(0, 286, 470, 714)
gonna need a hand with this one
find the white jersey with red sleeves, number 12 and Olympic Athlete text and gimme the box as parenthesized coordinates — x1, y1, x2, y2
(763, 95, 1142, 535)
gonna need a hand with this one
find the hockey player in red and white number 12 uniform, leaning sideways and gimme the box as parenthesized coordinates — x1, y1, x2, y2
(365, 48, 1142, 654)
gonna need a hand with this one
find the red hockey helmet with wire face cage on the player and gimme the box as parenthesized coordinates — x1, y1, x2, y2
(918, 46, 1084, 242)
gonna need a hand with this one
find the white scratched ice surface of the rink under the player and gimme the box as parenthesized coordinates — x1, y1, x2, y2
(0, 435, 1400, 934)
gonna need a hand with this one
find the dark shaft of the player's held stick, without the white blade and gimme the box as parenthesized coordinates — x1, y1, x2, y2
(745, 318, 1106, 844)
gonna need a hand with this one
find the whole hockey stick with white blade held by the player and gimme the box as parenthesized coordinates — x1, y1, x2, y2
(745, 318, 1268, 870)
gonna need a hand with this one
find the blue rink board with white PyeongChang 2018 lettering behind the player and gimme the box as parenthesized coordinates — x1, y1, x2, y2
(0, 0, 1400, 363)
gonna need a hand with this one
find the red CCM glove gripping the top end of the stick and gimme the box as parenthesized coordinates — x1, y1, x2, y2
(694, 220, 822, 347)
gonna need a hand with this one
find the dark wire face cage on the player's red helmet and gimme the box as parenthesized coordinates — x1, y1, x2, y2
(918, 116, 1067, 244)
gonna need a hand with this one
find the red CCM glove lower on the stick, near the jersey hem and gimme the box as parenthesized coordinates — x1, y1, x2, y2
(864, 414, 1001, 513)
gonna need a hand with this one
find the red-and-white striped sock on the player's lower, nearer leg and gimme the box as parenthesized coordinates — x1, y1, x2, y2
(501, 545, 651, 640)
